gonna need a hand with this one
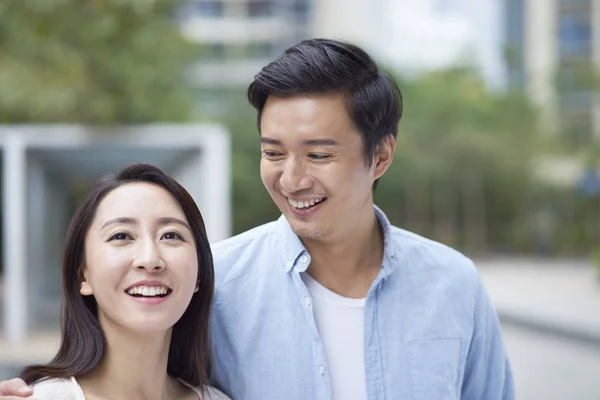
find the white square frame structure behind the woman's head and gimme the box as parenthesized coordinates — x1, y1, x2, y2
(0, 124, 231, 345)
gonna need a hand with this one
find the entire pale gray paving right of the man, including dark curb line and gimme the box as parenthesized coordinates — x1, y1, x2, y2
(476, 258, 600, 400)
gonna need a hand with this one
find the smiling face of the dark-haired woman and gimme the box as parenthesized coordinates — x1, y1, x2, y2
(80, 182, 198, 332)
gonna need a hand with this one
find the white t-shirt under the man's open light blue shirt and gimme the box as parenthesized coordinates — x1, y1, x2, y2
(301, 273, 367, 400)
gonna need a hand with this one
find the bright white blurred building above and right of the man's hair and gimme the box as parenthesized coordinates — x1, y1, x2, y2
(312, 0, 505, 88)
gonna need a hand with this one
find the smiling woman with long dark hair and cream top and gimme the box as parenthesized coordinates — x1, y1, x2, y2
(21, 164, 227, 400)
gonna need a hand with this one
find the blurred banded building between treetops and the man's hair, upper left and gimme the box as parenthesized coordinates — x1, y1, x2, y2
(179, 0, 313, 117)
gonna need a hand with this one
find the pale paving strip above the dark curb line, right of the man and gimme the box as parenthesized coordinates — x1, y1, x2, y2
(477, 258, 600, 347)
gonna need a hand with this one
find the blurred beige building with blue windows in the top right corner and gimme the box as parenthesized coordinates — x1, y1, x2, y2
(504, 0, 600, 142)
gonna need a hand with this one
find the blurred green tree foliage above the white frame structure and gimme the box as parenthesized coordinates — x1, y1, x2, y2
(0, 0, 197, 124)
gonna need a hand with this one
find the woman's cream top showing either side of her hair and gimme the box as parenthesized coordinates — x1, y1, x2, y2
(33, 377, 231, 400)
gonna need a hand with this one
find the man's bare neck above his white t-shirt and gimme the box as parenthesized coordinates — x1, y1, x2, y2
(302, 207, 383, 298)
